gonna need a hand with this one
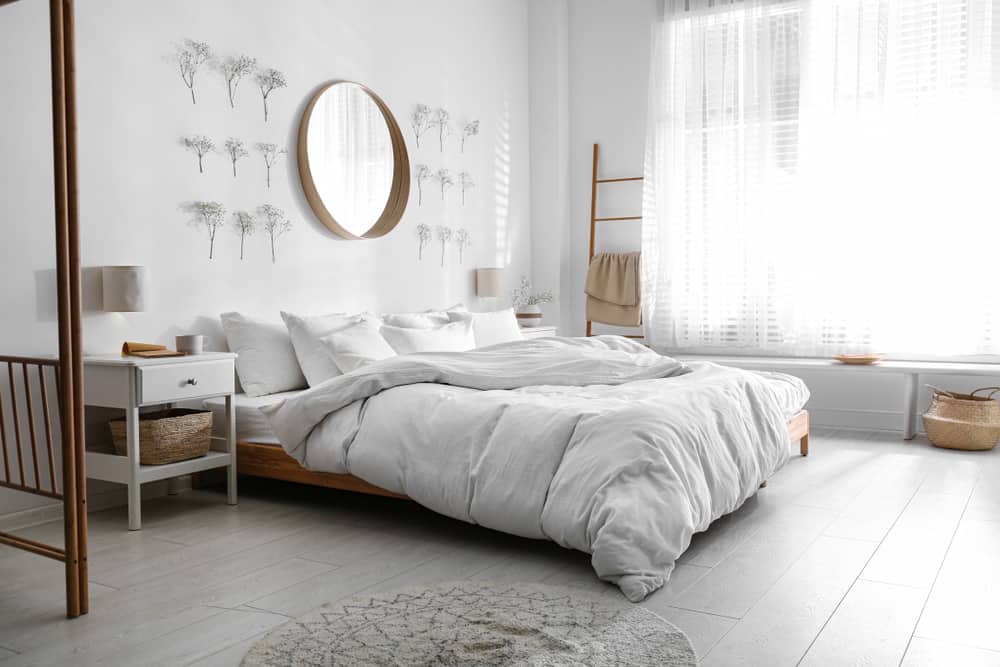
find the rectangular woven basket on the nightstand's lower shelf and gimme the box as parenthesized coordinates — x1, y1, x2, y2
(111, 408, 212, 466)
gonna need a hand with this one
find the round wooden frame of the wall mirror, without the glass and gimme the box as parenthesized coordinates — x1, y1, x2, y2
(297, 79, 410, 241)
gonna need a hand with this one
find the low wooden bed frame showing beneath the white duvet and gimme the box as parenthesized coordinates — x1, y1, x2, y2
(236, 410, 809, 498)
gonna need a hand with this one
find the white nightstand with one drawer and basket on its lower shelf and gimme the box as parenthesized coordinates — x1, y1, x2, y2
(83, 352, 236, 530)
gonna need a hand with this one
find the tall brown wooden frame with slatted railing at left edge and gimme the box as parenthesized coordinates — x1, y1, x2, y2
(0, 0, 90, 618)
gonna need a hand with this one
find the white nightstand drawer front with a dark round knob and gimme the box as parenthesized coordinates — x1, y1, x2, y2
(139, 359, 235, 405)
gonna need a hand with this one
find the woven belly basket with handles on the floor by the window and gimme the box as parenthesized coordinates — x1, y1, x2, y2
(924, 385, 1000, 450)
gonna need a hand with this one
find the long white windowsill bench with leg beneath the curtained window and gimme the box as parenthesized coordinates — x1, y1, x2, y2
(671, 354, 1000, 440)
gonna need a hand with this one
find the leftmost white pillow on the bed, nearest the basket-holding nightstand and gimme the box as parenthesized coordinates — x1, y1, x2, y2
(219, 313, 306, 396)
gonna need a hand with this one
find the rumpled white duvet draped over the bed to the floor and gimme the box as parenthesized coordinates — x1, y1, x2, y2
(264, 336, 808, 601)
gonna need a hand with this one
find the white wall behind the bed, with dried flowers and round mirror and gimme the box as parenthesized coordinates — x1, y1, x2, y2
(0, 0, 532, 514)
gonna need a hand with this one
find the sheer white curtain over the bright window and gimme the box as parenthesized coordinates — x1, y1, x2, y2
(643, 0, 1000, 356)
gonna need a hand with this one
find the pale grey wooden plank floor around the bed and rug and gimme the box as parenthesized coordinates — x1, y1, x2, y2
(0, 432, 1000, 667)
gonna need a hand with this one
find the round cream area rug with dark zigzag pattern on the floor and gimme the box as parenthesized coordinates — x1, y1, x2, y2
(243, 581, 697, 667)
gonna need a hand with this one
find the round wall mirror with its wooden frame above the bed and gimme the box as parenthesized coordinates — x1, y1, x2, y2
(298, 81, 410, 239)
